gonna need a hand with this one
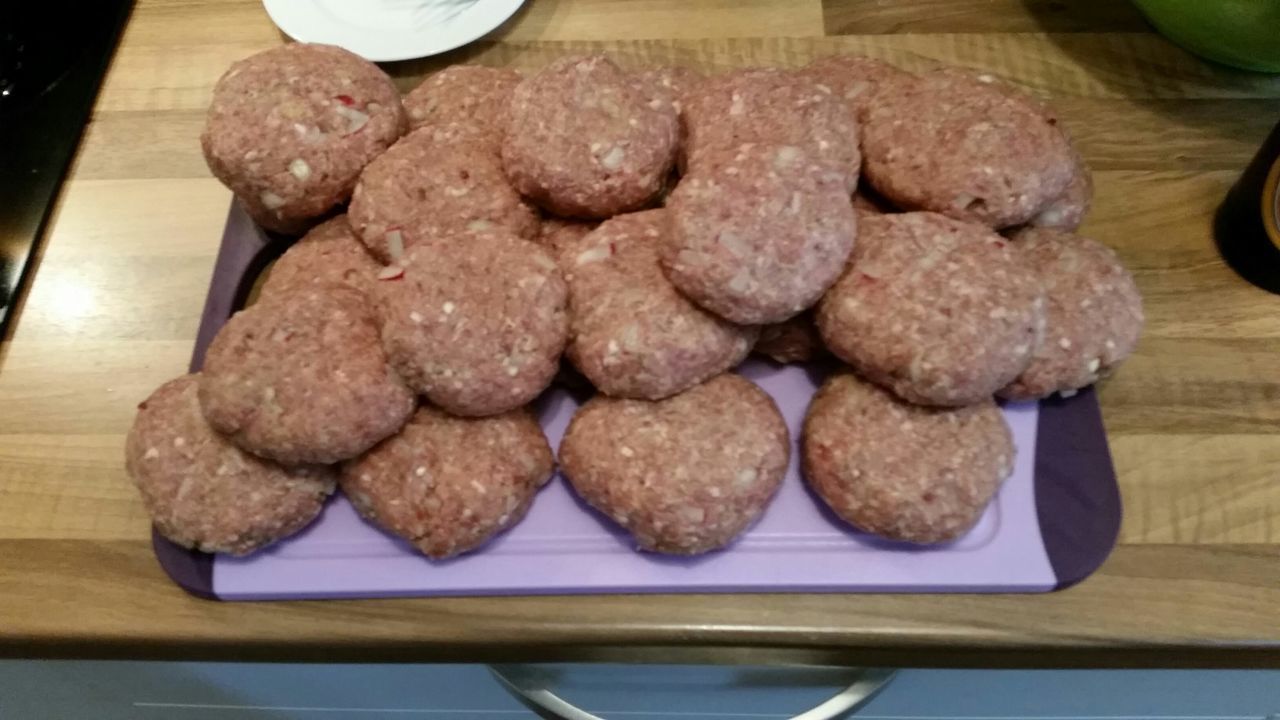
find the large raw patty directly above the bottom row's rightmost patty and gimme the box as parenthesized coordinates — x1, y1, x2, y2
(818, 213, 1044, 405)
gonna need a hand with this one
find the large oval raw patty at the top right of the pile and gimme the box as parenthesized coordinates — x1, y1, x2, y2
(863, 72, 1074, 228)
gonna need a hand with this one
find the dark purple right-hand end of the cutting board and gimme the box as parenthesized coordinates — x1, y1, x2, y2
(1034, 388, 1121, 591)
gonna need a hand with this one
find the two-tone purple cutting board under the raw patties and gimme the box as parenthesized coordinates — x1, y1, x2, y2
(154, 205, 1120, 600)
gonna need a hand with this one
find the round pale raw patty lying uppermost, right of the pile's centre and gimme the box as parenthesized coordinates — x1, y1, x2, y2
(662, 145, 856, 324)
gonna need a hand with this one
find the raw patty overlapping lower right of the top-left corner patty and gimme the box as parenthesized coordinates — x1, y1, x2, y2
(349, 126, 539, 263)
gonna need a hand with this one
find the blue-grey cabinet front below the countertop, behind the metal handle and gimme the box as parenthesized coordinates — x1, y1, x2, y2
(0, 660, 1280, 720)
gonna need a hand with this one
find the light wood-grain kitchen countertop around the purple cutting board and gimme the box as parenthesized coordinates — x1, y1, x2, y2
(0, 0, 1280, 666)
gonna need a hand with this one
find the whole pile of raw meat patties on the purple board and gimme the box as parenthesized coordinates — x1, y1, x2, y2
(127, 44, 1143, 557)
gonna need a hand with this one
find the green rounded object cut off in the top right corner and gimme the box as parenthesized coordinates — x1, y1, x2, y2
(1133, 0, 1280, 73)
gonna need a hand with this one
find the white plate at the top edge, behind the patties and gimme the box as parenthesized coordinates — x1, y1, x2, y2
(262, 0, 525, 63)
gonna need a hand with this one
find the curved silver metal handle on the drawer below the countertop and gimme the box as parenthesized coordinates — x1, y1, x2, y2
(489, 665, 895, 720)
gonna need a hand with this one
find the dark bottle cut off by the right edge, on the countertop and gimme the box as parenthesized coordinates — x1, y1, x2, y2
(1213, 124, 1280, 295)
